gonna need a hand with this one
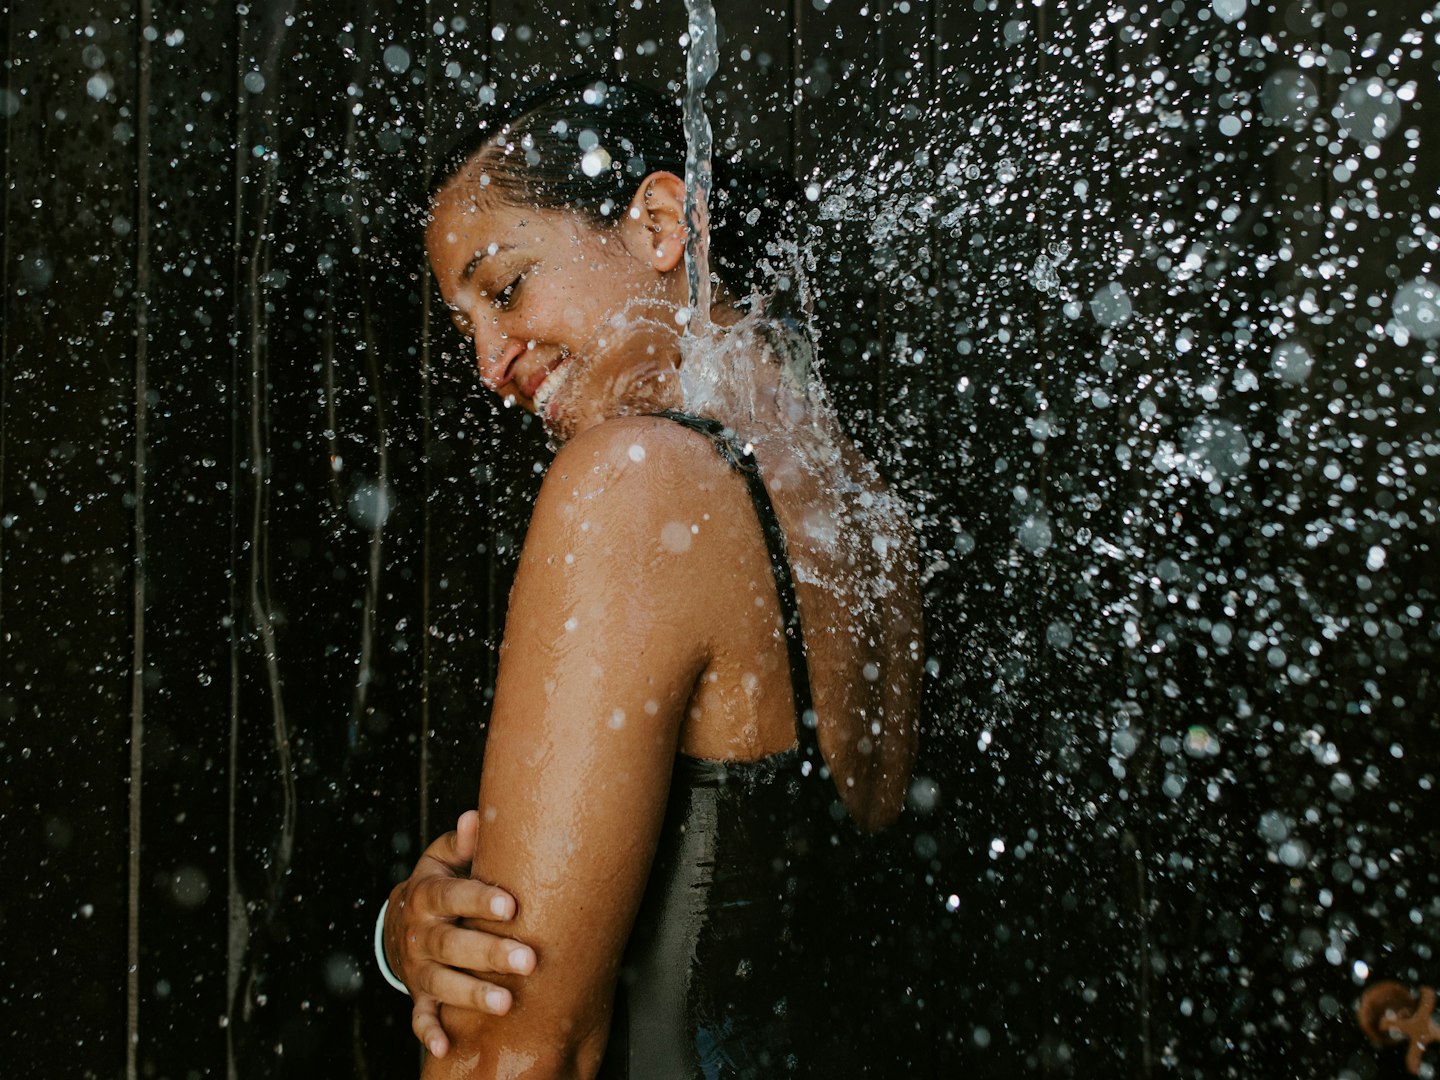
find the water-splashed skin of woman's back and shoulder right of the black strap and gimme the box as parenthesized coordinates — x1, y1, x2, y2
(681, 315, 923, 828)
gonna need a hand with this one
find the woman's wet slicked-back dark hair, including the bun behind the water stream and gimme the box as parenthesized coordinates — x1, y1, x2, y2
(429, 73, 805, 314)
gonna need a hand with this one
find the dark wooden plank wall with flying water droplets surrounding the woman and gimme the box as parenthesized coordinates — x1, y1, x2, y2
(0, 0, 1440, 1077)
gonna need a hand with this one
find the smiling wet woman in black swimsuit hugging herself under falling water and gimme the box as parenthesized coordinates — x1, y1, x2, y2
(386, 72, 920, 1079)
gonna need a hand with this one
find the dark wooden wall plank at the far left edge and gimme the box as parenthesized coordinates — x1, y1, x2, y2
(0, 3, 141, 1076)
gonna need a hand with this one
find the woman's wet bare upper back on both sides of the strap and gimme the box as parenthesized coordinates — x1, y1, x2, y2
(656, 315, 923, 831)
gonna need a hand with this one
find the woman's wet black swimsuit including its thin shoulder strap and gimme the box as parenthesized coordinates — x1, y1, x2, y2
(600, 412, 854, 1080)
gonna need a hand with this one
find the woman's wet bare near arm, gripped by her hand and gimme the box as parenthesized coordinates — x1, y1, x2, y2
(423, 419, 706, 1080)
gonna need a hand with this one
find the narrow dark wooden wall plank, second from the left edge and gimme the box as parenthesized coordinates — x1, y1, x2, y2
(135, 0, 246, 1076)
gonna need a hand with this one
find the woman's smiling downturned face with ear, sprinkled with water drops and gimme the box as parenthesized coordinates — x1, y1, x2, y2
(425, 166, 685, 438)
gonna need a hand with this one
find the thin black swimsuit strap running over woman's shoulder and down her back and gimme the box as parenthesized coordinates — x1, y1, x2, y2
(652, 409, 825, 768)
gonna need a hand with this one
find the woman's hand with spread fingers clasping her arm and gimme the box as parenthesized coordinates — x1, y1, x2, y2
(384, 811, 536, 1057)
